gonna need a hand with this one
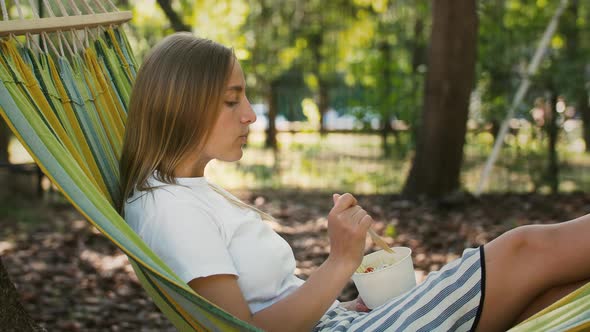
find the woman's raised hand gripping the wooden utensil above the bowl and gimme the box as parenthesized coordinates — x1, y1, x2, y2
(328, 193, 373, 274)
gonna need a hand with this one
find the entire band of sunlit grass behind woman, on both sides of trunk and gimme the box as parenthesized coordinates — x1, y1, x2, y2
(9, 128, 590, 194)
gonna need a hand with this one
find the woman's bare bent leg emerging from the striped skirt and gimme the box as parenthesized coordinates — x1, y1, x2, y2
(477, 215, 590, 331)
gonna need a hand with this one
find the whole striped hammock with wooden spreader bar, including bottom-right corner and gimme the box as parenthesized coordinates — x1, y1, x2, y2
(0, 0, 590, 331)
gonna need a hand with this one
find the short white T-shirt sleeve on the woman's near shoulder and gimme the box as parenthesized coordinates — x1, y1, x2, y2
(151, 202, 238, 283)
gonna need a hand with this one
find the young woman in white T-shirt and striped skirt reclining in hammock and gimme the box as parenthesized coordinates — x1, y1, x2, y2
(120, 34, 590, 331)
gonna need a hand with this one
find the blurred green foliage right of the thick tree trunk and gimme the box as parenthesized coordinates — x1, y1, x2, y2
(473, 0, 590, 122)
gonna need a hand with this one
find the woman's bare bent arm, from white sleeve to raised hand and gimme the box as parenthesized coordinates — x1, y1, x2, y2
(189, 194, 372, 331)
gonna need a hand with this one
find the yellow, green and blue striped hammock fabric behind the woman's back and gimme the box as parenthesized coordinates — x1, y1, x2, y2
(0, 28, 257, 331)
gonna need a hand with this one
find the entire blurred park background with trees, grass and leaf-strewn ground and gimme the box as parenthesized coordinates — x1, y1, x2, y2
(0, 0, 590, 331)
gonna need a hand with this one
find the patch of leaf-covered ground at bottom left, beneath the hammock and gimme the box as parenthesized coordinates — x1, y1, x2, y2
(0, 201, 175, 332)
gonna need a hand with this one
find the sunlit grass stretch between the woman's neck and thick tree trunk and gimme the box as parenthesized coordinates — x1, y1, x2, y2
(206, 132, 410, 193)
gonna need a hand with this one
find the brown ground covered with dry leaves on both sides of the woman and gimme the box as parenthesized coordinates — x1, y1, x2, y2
(0, 191, 590, 331)
